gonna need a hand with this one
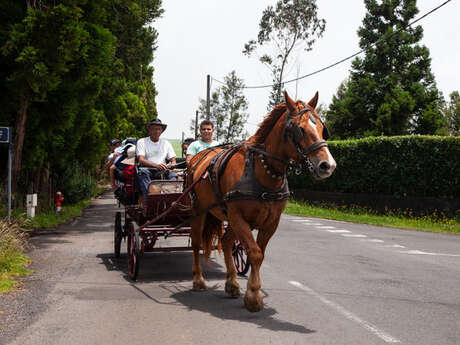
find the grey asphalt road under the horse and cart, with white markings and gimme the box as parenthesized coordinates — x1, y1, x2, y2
(0, 193, 460, 345)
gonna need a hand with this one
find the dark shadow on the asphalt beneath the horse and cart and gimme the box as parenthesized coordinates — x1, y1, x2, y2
(98, 252, 315, 334)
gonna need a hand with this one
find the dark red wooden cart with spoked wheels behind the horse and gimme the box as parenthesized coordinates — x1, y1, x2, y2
(114, 169, 249, 280)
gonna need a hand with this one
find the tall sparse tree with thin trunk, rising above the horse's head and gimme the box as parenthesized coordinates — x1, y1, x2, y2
(243, 0, 326, 110)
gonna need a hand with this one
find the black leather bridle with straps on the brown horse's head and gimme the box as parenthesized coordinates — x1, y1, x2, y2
(245, 102, 329, 180)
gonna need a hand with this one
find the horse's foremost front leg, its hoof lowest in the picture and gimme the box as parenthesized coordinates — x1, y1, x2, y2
(229, 213, 264, 312)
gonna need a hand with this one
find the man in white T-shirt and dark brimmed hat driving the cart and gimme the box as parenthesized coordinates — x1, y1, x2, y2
(136, 119, 177, 197)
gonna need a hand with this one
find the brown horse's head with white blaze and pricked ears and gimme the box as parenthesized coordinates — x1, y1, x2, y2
(284, 92, 336, 180)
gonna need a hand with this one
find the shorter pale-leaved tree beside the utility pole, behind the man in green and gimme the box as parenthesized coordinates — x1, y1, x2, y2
(196, 71, 249, 143)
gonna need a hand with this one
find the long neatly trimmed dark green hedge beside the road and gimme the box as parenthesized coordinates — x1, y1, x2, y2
(288, 135, 460, 198)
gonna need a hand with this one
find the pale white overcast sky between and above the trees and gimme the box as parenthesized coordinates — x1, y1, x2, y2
(152, 0, 460, 139)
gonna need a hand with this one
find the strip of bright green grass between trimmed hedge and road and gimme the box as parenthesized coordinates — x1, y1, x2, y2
(284, 200, 460, 234)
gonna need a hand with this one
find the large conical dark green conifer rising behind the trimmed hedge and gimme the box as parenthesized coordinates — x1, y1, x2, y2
(327, 0, 444, 138)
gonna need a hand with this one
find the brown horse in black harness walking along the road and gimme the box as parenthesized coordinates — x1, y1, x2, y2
(187, 92, 336, 312)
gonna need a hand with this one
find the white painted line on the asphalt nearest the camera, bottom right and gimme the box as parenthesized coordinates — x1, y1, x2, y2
(289, 280, 401, 343)
